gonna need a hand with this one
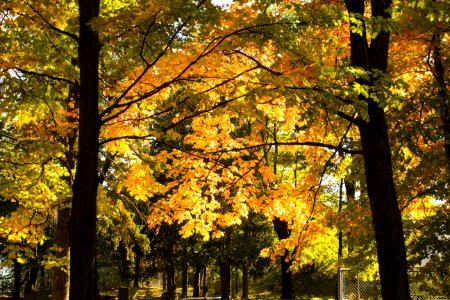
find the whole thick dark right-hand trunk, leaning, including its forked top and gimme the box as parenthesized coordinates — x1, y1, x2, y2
(345, 0, 410, 300)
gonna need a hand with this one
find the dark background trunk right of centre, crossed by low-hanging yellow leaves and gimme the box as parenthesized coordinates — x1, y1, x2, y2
(273, 218, 294, 299)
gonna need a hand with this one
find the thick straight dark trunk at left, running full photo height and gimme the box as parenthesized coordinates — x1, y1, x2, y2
(69, 0, 100, 300)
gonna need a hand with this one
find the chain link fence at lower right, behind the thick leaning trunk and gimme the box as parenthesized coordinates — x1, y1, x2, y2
(338, 269, 448, 300)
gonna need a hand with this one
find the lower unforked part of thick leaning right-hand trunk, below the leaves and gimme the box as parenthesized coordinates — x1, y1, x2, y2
(360, 101, 410, 300)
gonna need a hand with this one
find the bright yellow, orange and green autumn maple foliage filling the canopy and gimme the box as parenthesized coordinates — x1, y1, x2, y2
(0, 0, 448, 298)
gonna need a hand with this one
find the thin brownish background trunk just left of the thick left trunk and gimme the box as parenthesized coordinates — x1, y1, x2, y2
(52, 207, 70, 300)
